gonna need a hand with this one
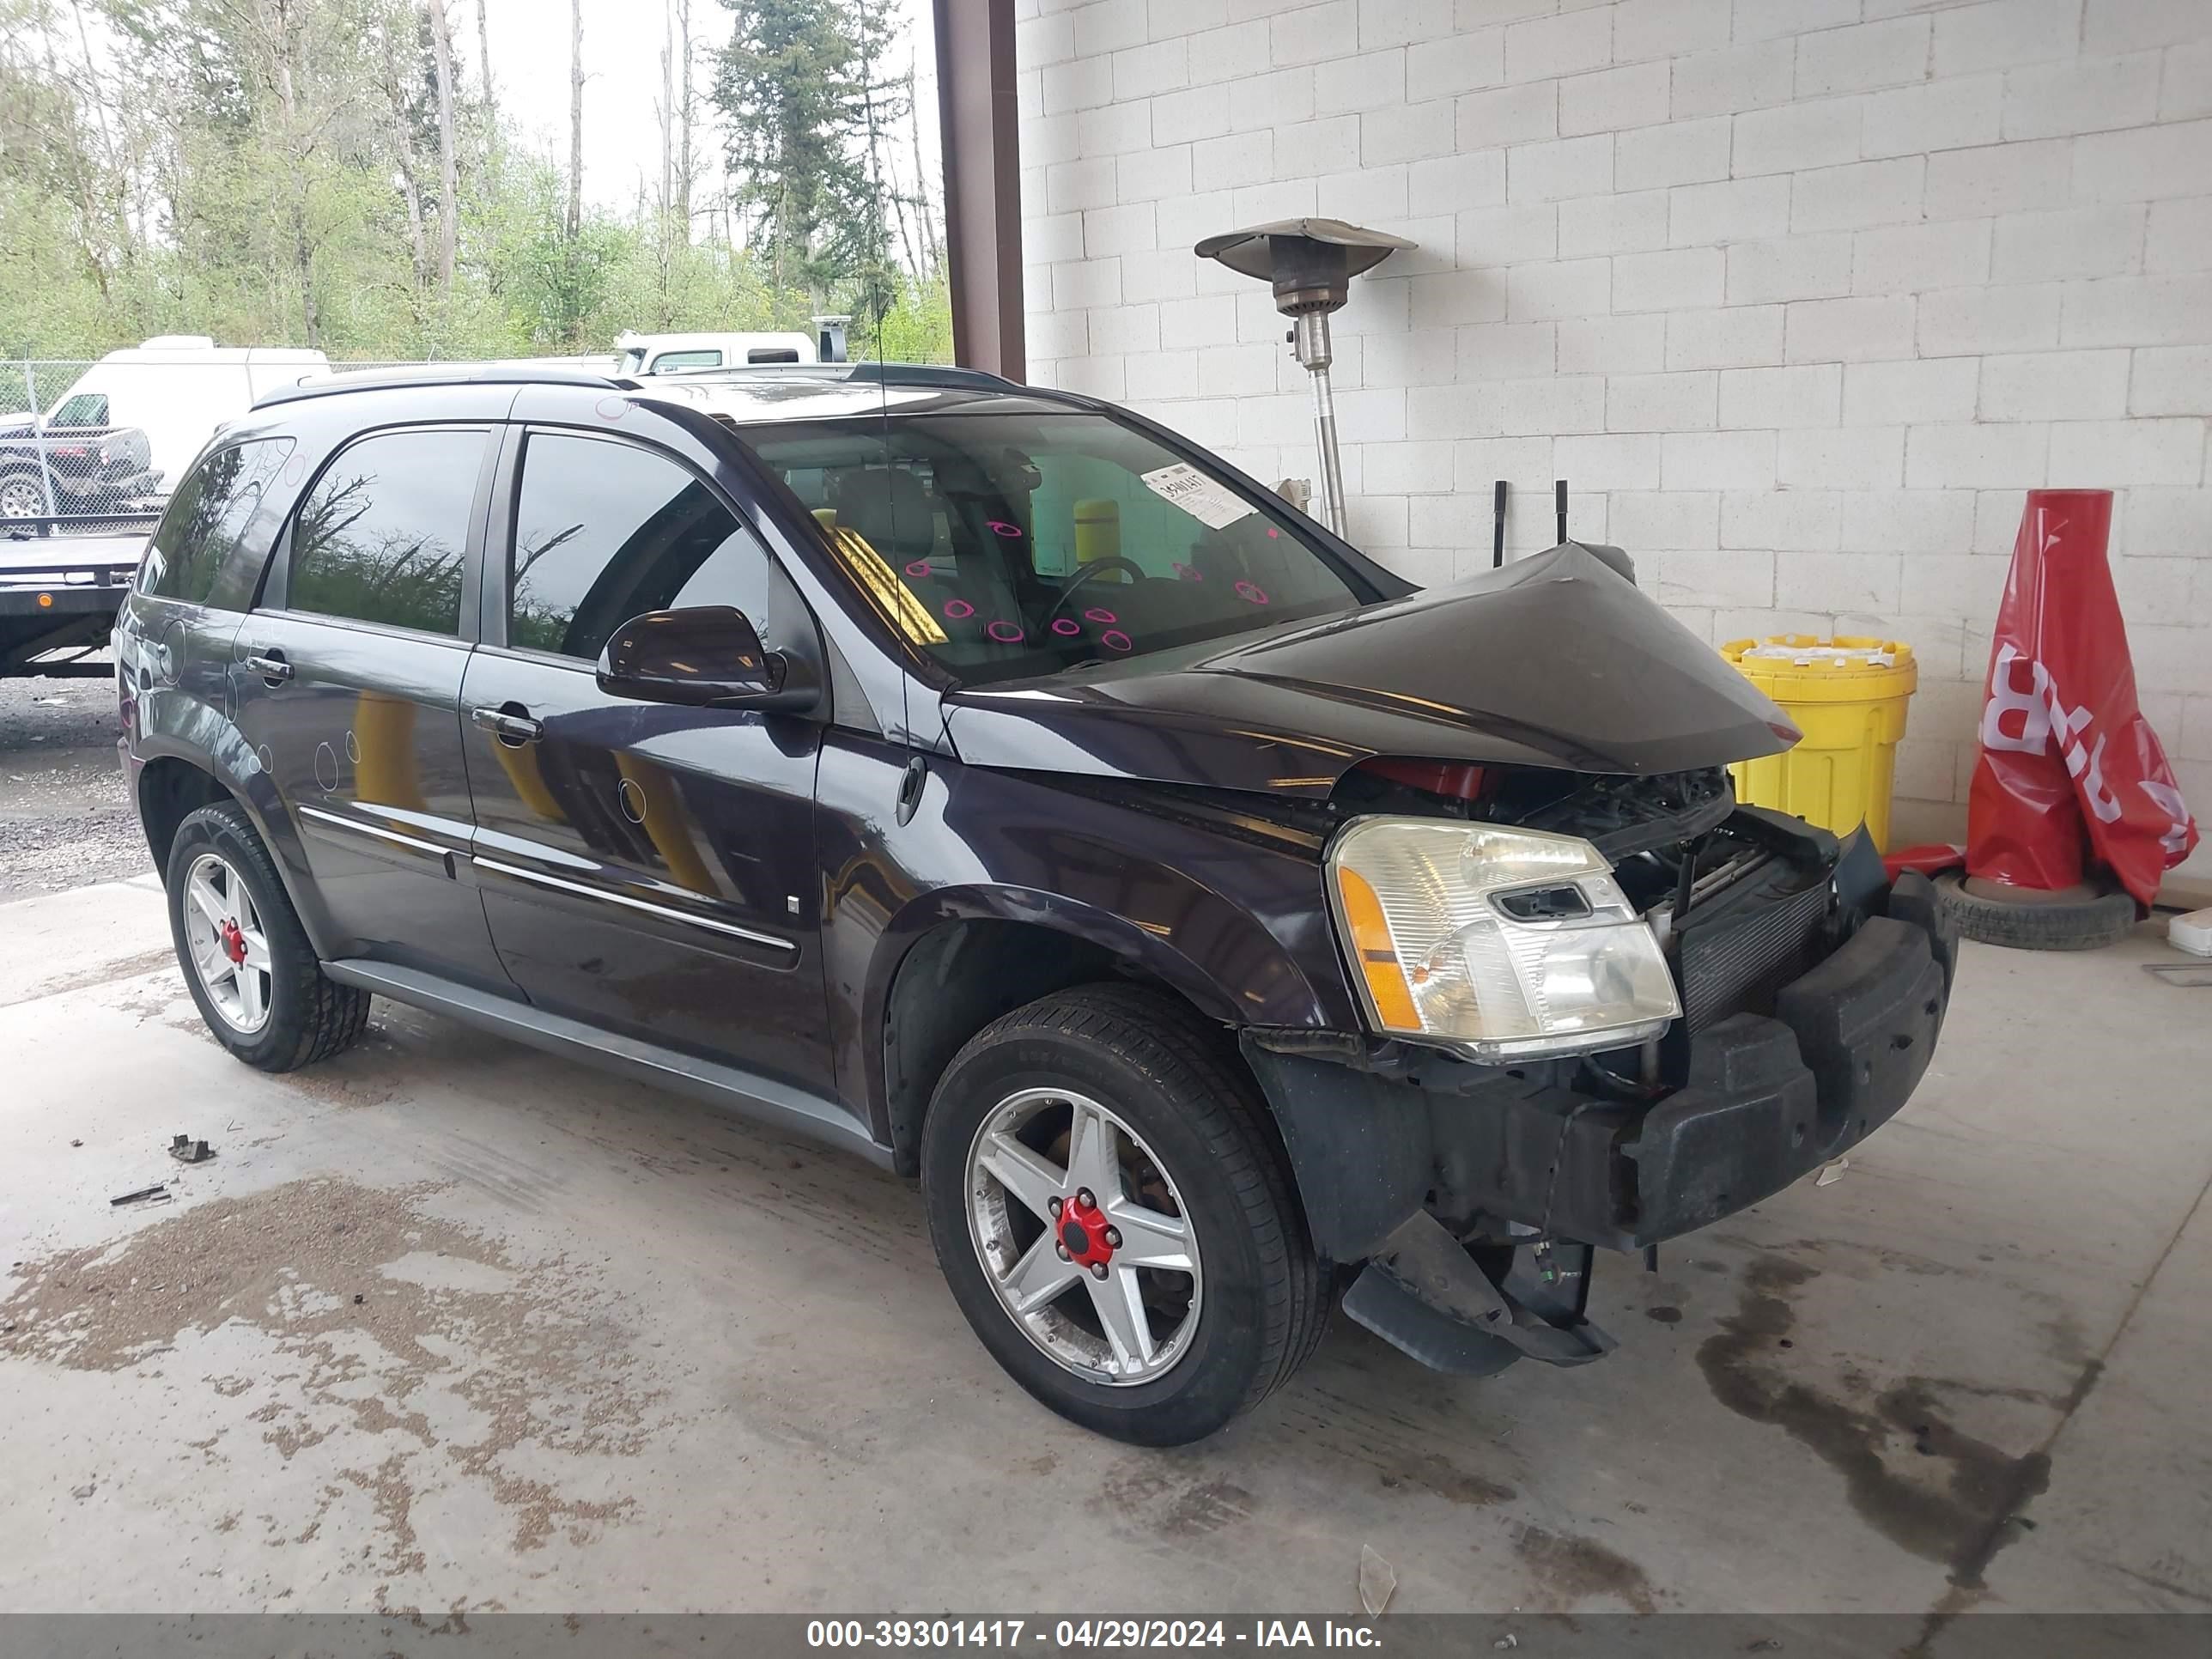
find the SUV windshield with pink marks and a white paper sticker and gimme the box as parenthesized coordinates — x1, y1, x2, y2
(744, 411, 1380, 686)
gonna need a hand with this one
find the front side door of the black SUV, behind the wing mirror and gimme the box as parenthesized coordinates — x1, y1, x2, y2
(462, 427, 832, 1095)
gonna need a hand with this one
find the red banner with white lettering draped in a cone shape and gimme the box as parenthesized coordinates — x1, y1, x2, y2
(1966, 489, 2197, 914)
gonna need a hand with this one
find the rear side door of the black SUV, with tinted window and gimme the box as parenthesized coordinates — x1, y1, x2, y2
(230, 425, 514, 995)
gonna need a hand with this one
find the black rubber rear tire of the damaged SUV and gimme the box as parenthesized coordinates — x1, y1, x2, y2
(161, 801, 369, 1071)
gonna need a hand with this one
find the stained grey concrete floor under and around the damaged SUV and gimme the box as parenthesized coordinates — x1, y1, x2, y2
(0, 876, 2212, 1650)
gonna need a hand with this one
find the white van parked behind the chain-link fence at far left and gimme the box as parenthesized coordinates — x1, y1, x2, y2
(46, 334, 330, 491)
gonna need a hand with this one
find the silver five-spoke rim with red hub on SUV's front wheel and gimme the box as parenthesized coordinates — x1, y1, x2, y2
(967, 1088, 1206, 1387)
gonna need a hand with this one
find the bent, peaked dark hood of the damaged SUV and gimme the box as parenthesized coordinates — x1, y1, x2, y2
(945, 542, 1796, 799)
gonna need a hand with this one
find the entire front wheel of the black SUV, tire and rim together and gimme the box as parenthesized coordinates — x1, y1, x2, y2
(922, 984, 1328, 1447)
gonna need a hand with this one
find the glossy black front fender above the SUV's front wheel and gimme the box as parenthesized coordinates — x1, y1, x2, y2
(818, 732, 1358, 1176)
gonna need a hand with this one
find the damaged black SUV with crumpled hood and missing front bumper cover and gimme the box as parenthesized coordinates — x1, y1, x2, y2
(118, 365, 1954, 1444)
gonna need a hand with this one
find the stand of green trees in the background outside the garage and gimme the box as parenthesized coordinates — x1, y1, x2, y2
(0, 0, 951, 362)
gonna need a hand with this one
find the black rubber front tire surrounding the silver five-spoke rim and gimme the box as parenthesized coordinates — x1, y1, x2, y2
(922, 984, 1329, 1447)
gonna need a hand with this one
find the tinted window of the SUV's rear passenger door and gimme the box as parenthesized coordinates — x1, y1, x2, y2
(285, 429, 484, 635)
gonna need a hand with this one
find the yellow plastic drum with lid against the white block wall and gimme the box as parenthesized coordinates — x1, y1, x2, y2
(1721, 633, 1920, 852)
